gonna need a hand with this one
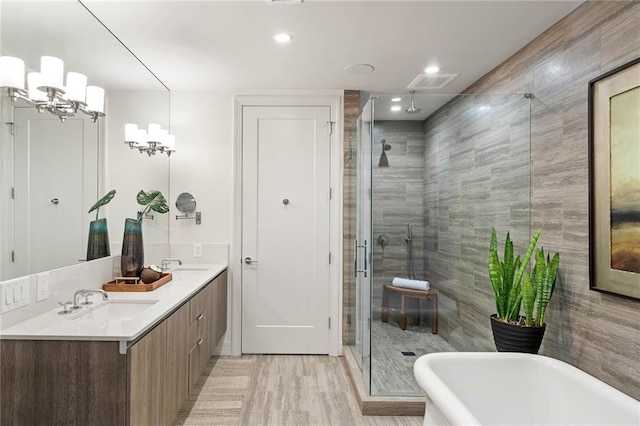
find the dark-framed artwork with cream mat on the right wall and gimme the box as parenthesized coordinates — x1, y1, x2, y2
(589, 58, 640, 299)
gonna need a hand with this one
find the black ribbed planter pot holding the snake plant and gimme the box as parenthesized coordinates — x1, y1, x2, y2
(491, 314, 547, 354)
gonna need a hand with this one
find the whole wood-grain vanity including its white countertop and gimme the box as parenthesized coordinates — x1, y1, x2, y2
(0, 265, 227, 426)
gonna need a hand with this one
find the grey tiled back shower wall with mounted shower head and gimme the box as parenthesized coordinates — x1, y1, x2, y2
(371, 121, 425, 320)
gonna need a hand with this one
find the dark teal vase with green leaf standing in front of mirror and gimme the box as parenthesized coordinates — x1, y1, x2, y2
(120, 190, 169, 277)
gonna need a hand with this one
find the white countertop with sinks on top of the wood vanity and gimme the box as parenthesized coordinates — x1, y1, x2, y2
(0, 264, 227, 344)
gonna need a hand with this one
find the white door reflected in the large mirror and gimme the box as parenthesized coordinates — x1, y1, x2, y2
(14, 107, 98, 276)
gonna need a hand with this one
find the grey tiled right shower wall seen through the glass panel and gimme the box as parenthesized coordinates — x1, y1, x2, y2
(424, 95, 530, 351)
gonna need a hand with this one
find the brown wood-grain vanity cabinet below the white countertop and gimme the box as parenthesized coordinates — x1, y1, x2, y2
(0, 271, 227, 426)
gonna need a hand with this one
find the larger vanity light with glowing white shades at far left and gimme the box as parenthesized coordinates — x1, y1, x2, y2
(0, 56, 104, 123)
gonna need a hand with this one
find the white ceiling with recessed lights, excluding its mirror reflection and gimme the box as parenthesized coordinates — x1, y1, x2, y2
(1, 0, 582, 119)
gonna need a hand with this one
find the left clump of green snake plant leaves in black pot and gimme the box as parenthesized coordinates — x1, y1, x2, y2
(489, 228, 542, 322)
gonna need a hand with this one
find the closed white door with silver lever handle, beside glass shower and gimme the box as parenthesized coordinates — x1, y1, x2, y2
(242, 106, 331, 354)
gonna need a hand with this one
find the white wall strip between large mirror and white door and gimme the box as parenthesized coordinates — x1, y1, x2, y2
(170, 92, 234, 248)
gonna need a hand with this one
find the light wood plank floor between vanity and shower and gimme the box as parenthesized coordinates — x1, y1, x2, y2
(177, 355, 423, 426)
